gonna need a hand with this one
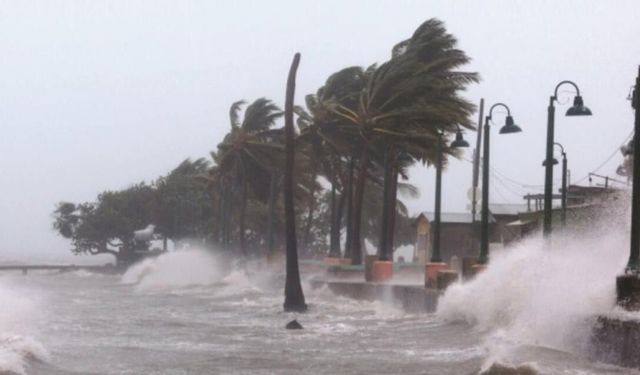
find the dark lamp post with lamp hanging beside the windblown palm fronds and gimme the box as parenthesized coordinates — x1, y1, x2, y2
(425, 128, 469, 287)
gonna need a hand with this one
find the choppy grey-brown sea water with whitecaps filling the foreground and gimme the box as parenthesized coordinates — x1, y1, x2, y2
(0, 245, 640, 375)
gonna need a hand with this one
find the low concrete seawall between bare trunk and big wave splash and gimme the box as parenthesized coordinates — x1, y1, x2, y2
(311, 279, 442, 313)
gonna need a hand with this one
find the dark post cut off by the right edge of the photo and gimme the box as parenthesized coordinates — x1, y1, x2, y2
(626, 67, 640, 274)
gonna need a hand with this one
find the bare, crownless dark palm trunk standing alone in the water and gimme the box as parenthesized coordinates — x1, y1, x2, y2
(283, 53, 307, 312)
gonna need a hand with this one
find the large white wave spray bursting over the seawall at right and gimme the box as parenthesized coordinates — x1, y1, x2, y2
(437, 217, 628, 359)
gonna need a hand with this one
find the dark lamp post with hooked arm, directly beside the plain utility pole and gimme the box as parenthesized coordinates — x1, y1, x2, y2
(478, 103, 522, 265)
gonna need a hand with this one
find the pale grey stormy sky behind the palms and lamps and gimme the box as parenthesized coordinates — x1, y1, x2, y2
(0, 0, 640, 259)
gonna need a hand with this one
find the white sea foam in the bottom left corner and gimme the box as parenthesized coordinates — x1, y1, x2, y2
(0, 280, 48, 374)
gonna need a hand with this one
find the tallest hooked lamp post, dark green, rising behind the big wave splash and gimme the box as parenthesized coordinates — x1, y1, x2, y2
(543, 81, 591, 237)
